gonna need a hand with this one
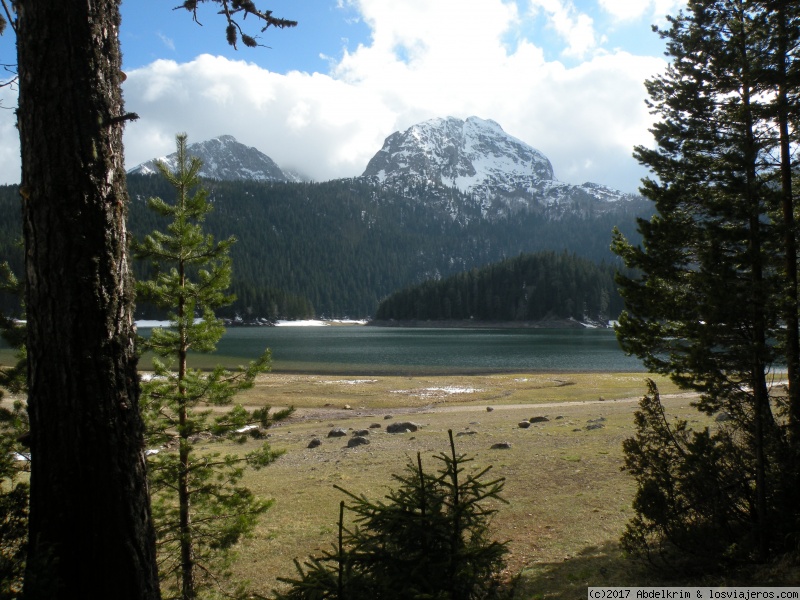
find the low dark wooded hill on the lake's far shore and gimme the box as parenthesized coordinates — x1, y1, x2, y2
(376, 252, 622, 323)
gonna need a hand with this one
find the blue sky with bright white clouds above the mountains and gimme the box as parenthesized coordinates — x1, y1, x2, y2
(0, 0, 684, 191)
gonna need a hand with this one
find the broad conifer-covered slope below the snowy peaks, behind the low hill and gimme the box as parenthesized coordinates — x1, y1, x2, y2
(0, 175, 652, 318)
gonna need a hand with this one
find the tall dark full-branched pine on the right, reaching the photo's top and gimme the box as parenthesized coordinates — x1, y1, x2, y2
(614, 0, 798, 563)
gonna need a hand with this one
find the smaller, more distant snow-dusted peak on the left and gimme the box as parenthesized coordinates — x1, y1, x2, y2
(128, 135, 302, 181)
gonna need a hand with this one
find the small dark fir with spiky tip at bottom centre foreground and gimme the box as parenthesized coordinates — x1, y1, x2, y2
(277, 431, 507, 600)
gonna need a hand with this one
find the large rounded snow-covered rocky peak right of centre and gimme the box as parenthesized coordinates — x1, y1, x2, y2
(363, 117, 637, 216)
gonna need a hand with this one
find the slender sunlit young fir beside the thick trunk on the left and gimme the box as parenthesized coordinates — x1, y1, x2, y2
(136, 135, 291, 600)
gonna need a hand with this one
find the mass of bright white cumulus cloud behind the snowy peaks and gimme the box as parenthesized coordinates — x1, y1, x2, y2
(0, 0, 666, 191)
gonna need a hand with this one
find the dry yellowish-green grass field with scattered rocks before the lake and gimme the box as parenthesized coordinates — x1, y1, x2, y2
(198, 373, 712, 599)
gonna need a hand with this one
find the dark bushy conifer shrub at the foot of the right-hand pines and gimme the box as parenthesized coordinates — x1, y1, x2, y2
(622, 379, 755, 571)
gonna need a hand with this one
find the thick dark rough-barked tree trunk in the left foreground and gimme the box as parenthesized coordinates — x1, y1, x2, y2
(17, 0, 159, 600)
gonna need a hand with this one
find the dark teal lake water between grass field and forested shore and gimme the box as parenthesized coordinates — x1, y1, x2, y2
(183, 326, 644, 374)
